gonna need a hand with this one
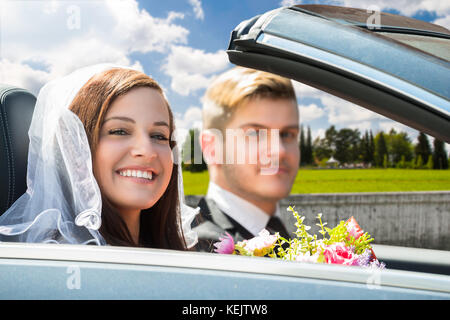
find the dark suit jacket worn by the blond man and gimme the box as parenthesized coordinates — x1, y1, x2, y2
(192, 197, 290, 252)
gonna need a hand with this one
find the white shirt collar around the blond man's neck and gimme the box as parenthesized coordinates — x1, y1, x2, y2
(206, 181, 280, 236)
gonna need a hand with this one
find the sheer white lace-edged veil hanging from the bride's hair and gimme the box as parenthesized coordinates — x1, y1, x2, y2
(0, 64, 197, 248)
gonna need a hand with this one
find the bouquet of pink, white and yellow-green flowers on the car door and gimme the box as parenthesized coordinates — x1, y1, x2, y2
(214, 207, 385, 269)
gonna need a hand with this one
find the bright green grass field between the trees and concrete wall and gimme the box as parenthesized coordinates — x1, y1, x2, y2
(183, 169, 450, 195)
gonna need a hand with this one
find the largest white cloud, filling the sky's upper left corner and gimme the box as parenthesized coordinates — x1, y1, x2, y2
(0, 0, 189, 92)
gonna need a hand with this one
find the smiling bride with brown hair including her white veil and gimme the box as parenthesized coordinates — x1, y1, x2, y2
(0, 64, 197, 250)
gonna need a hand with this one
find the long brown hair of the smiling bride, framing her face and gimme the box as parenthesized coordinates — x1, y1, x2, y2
(69, 68, 186, 250)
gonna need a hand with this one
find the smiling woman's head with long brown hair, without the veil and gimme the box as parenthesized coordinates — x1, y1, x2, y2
(69, 69, 184, 249)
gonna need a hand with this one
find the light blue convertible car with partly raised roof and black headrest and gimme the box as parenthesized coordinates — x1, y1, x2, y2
(0, 5, 450, 300)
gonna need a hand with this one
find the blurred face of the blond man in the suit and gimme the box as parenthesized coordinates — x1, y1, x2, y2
(220, 98, 300, 203)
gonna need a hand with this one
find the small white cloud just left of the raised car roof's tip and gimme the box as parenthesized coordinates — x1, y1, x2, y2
(162, 46, 229, 96)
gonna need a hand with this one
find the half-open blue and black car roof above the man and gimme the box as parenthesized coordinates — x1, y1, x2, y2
(227, 5, 450, 143)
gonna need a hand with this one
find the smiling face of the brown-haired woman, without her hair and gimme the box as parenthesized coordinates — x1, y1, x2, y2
(94, 87, 173, 215)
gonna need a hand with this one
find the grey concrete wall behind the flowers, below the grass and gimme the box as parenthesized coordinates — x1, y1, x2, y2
(186, 191, 450, 250)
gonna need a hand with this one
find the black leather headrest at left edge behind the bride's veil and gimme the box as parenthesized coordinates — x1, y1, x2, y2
(0, 84, 36, 215)
